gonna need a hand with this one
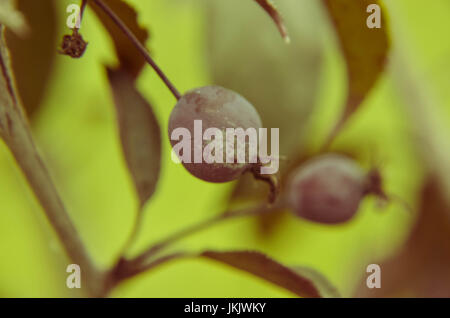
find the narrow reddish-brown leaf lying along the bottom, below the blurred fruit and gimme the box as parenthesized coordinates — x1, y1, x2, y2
(201, 251, 332, 298)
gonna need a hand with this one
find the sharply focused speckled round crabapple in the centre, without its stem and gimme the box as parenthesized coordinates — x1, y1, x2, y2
(169, 86, 262, 182)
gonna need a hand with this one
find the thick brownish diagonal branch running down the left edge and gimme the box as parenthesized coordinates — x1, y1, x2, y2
(0, 25, 99, 295)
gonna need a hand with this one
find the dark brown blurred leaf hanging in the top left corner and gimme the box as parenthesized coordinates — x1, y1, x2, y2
(6, 0, 58, 116)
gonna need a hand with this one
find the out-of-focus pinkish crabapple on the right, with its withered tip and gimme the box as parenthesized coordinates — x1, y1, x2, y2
(288, 154, 376, 224)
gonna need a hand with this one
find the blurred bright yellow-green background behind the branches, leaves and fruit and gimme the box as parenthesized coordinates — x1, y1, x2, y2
(0, 0, 450, 297)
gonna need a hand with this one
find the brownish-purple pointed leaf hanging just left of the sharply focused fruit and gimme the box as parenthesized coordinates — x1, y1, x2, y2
(107, 68, 161, 207)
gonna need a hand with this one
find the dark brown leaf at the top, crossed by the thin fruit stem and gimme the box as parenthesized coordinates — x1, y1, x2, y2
(91, 0, 148, 78)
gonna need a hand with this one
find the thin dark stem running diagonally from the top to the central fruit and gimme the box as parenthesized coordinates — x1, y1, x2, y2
(91, 0, 181, 100)
